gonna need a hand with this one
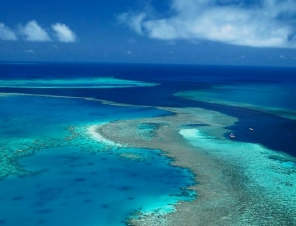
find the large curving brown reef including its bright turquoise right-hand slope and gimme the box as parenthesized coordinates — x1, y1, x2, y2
(97, 108, 296, 226)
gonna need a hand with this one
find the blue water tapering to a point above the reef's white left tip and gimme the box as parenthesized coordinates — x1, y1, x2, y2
(0, 96, 168, 154)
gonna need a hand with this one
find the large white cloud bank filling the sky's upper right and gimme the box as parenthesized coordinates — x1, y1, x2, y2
(119, 0, 296, 48)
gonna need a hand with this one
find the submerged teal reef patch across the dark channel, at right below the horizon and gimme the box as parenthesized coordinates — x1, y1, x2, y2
(175, 85, 296, 120)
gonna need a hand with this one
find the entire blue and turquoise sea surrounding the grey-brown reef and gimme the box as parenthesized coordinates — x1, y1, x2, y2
(0, 63, 296, 226)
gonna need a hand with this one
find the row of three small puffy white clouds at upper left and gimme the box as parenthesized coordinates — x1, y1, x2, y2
(0, 20, 77, 43)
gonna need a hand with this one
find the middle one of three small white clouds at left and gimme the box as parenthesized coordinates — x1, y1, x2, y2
(19, 20, 51, 42)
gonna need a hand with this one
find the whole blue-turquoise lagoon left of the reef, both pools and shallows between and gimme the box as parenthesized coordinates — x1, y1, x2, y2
(0, 95, 195, 226)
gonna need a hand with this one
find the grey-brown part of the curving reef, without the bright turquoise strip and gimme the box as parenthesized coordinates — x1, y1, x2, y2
(96, 108, 296, 226)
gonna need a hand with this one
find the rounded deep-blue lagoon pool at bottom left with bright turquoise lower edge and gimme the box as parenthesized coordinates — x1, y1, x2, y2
(0, 147, 193, 226)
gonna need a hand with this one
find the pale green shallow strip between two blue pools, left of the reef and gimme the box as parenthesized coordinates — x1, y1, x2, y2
(0, 126, 106, 179)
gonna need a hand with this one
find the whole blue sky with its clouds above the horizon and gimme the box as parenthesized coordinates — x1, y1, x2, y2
(0, 0, 296, 66)
